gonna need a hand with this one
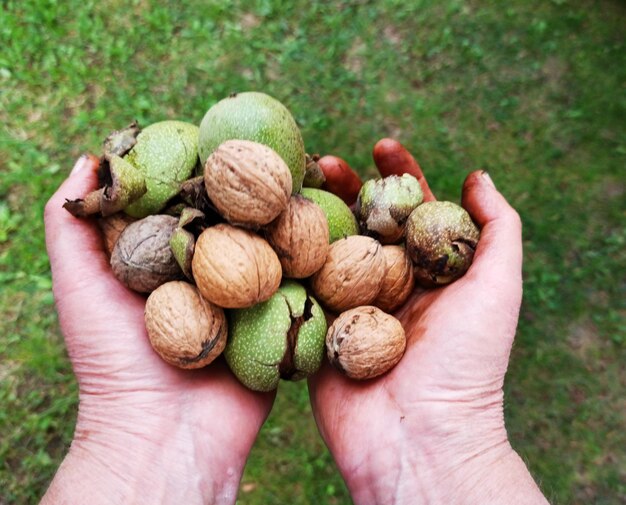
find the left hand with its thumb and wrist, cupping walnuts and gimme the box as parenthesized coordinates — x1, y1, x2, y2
(43, 157, 274, 504)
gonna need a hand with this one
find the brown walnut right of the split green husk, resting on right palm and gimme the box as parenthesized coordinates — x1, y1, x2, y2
(326, 306, 406, 379)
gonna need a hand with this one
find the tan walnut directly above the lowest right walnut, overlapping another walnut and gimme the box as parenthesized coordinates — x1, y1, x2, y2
(311, 235, 385, 312)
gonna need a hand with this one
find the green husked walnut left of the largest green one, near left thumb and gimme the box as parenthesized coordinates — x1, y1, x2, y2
(124, 121, 198, 218)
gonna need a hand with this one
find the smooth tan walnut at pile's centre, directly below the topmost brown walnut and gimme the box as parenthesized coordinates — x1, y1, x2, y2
(191, 224, 282, 309)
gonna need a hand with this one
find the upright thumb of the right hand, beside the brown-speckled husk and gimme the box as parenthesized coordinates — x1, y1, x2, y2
(463, 171, 522, 307)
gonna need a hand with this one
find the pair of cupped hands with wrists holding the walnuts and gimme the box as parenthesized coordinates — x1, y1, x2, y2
(43, 140, 543, 504)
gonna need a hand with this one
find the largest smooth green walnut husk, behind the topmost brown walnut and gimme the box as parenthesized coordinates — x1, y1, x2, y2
(199, 91, 305, 193)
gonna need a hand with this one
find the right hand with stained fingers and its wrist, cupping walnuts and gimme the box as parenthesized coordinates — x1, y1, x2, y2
(309, 139, 545, 504)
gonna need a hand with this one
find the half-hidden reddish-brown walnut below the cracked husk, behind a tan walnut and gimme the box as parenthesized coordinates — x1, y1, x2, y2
(373, 245, 415, 312)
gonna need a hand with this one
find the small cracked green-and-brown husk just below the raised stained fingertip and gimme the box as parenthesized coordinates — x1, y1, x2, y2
(354, 174, 424, 244)
